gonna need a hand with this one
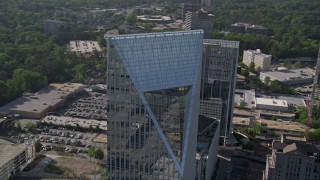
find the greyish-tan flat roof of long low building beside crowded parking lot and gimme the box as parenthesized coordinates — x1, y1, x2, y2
(0, 83, 83, 113)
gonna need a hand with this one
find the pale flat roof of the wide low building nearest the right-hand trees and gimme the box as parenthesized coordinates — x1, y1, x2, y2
(260, 68, 315, 81)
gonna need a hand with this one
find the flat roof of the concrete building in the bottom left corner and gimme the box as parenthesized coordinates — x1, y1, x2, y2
(0, 139, 27, 167)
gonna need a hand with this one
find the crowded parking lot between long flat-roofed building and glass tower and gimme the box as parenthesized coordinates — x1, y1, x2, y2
(60, 91, 107, 121)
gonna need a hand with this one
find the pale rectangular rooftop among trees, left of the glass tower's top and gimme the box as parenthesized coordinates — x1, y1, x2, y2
(69, 40, 101, 53)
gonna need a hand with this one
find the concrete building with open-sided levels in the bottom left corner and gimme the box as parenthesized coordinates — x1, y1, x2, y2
(0, 139, 35, 179)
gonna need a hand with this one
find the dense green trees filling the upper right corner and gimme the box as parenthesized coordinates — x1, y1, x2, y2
(213, 0, 320, 58)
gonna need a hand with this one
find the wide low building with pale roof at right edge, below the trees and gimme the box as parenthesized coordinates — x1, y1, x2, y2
(260, 68, 315, 86)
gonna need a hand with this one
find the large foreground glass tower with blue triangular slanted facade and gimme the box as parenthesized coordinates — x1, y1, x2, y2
(107, 30, 203, 180)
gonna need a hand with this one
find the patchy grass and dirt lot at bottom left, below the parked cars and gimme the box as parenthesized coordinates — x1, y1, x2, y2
(44, 157, 103, 177)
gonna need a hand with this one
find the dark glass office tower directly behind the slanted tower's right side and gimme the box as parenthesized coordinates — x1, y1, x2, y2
(200, 39, 239, 144)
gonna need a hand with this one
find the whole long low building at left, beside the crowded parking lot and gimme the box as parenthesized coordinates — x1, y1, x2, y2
(0, 83, 83, 119)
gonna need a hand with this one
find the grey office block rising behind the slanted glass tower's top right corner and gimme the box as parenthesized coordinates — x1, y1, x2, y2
(184, 11, 214, 39)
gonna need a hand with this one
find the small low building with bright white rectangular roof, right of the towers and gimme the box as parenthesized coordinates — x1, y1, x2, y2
(255, 98, 289, 112)
